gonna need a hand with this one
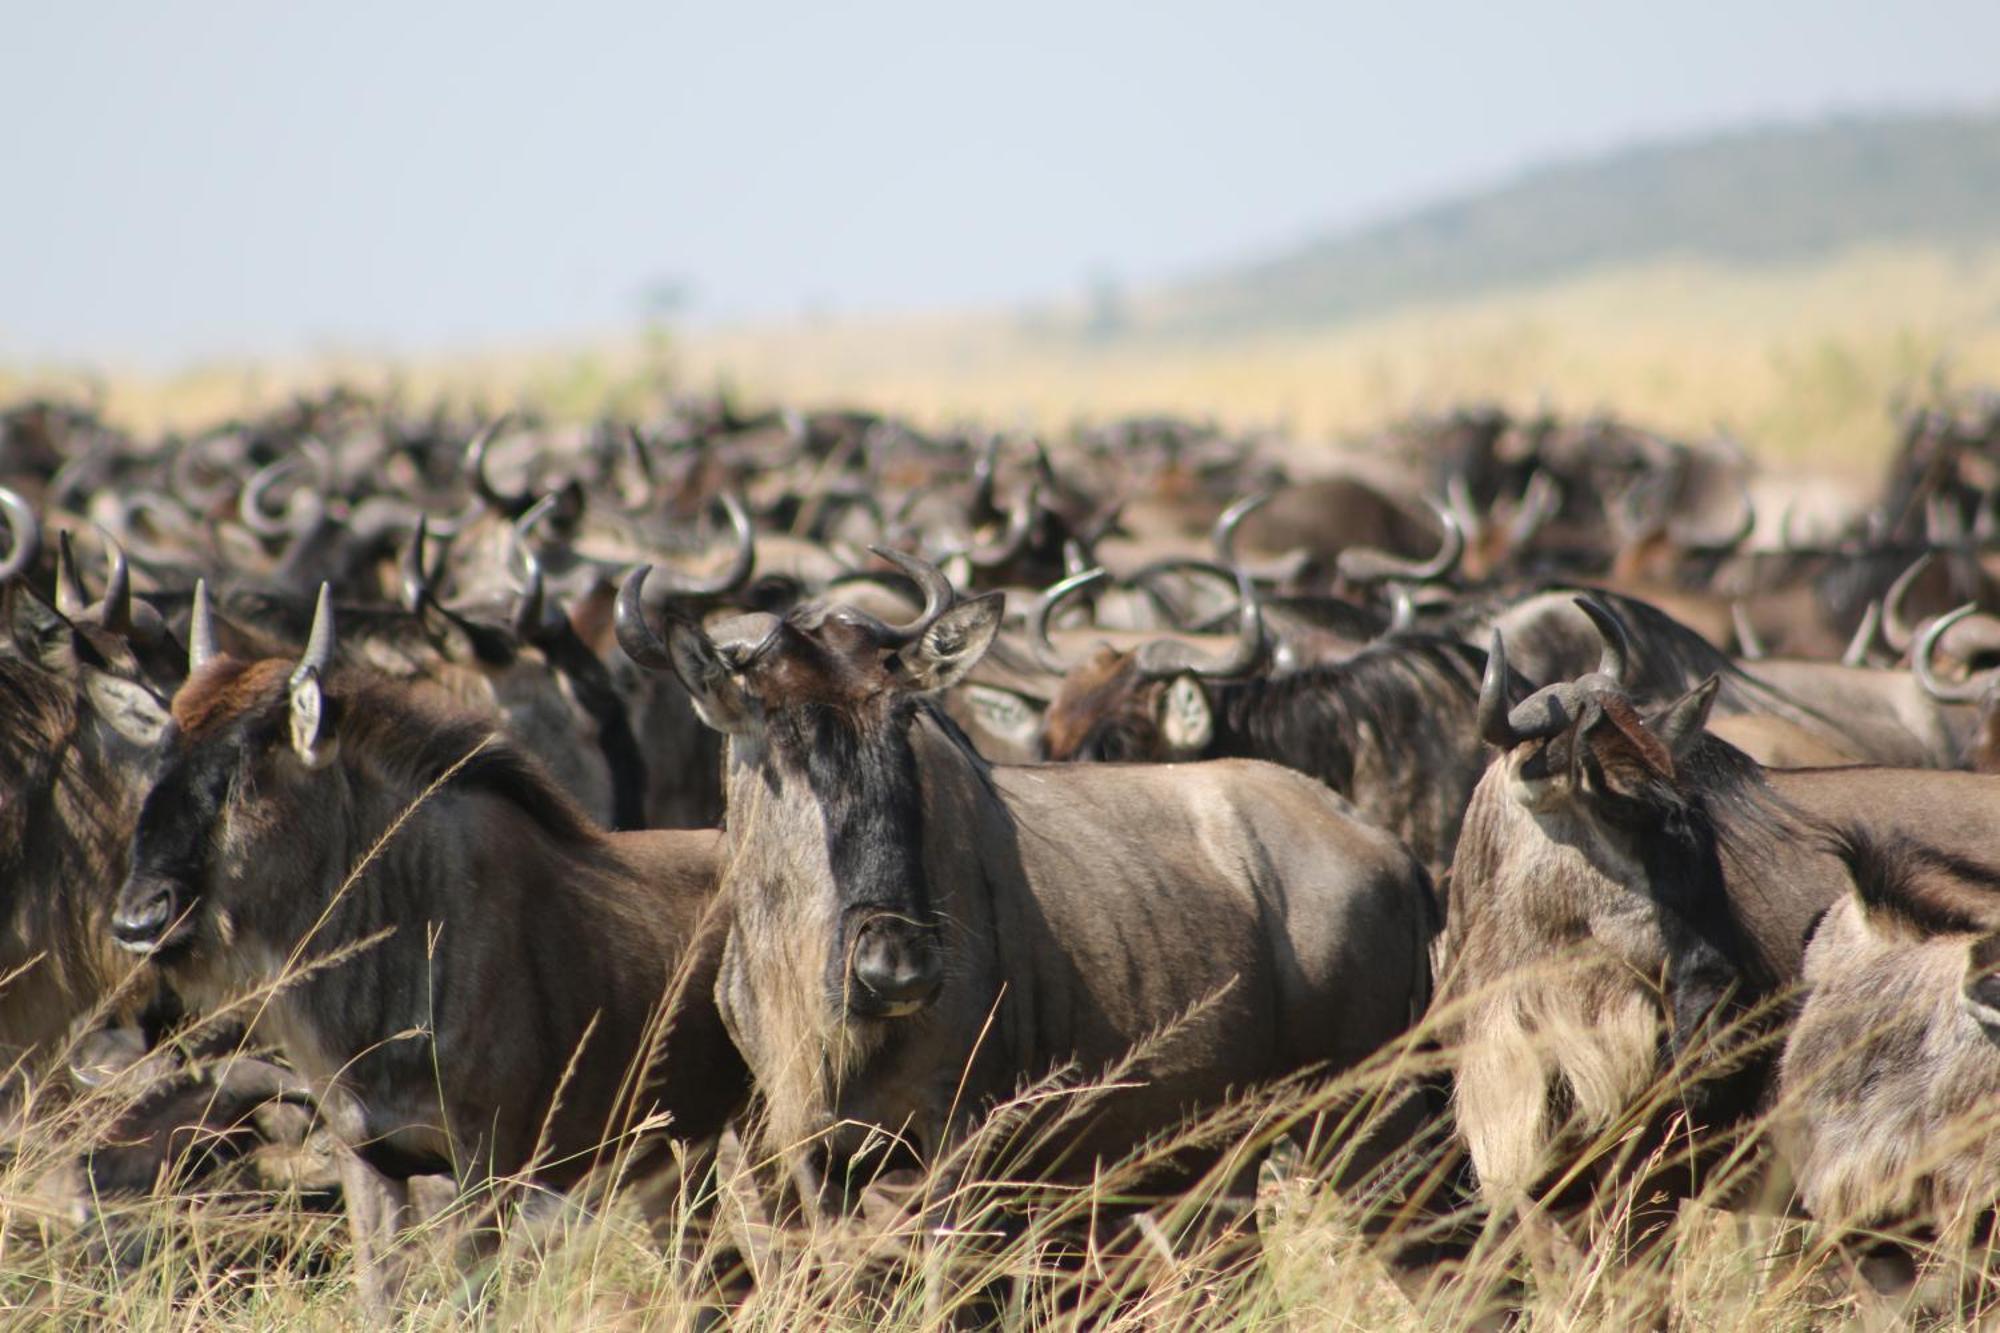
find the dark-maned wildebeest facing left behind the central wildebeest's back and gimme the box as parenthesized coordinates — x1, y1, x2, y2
(1042, 564, 1486, 873)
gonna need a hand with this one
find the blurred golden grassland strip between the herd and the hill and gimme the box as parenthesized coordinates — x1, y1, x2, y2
(0, 246, 2000, 472)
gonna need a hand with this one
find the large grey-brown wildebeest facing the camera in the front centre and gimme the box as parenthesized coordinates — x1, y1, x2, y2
(618, 554, 1434, 1209)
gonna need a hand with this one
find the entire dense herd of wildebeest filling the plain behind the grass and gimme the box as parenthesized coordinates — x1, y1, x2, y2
(0, 392, 2000, 1309)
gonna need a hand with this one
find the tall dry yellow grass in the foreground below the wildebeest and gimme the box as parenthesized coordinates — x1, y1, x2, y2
(0, 908, 2000, 1329)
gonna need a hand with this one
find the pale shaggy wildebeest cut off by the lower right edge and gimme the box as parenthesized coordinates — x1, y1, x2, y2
(1782, 831, 2000, 1299)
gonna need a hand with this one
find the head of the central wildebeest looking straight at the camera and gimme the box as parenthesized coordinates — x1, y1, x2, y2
(618, 552, 1002, 1021)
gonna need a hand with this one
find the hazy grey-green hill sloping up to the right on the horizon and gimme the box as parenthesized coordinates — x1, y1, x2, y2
(1132, 114, 2000, 334)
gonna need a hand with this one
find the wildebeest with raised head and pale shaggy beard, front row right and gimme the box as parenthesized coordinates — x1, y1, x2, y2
(1440, 598, 2000, 1264)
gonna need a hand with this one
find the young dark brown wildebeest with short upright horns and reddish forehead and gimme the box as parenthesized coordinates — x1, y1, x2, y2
(112, 588, 748, 1304)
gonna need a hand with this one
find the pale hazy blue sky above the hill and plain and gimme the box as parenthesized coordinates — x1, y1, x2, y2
(0, 0, 2000, 364)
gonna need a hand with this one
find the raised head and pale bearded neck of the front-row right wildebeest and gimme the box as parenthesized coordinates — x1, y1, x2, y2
(1444, 596, 1776, 1199)
